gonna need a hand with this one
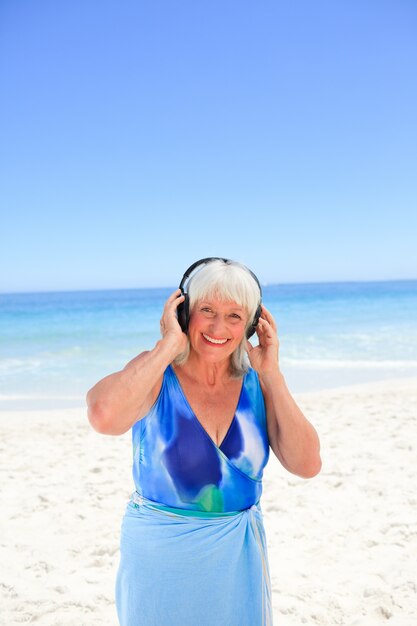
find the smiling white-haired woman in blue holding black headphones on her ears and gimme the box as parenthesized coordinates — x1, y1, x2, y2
(87, 258, 321, 626)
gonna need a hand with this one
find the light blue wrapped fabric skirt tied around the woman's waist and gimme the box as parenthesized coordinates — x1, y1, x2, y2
(115, 493, 272, 626)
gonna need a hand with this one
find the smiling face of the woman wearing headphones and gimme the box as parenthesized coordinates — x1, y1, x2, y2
(188, 298, 248, 362)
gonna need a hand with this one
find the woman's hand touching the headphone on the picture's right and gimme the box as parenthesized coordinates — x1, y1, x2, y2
(246, 305, 279, 374)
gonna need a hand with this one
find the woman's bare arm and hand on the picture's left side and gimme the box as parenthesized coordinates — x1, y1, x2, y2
(87, 290, 187, 435)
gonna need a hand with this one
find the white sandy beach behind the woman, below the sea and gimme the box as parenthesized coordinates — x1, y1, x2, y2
(0, 378, 417, 626)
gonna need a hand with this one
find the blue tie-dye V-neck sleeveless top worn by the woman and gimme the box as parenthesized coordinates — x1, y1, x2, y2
(132, 365, 269, 512)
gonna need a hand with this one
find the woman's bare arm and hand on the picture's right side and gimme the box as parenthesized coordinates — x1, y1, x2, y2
(247, 307, 321, 478)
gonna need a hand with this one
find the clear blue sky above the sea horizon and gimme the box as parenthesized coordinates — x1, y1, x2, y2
(0, 0, 417, 292)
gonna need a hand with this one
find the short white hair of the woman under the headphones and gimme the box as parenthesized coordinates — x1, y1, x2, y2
(174, 259, 261, 378)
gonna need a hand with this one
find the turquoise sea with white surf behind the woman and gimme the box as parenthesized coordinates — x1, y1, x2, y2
(0, 280, 417, 409)
